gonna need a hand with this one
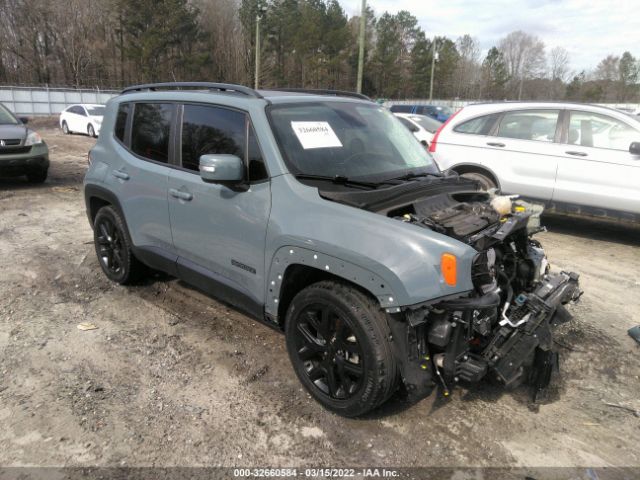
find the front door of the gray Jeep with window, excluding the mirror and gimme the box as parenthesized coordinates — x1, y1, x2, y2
(169, 104, 271, 309)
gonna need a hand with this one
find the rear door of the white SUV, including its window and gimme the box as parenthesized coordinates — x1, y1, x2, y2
(482, 109, 560, 201)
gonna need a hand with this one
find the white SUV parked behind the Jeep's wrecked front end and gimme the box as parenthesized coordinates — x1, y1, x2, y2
(430, 102, 640, 221)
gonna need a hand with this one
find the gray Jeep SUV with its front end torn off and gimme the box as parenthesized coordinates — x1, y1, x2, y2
(85, 83, 580, 416)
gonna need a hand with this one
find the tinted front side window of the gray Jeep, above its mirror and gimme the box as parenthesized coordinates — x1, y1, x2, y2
(181, 105, 247, 172)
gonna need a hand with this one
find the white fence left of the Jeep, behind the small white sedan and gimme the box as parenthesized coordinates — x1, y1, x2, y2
(0, 87, 119, 117)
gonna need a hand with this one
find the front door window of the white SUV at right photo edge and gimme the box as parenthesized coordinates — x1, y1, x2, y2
(568, 112, 640, 150)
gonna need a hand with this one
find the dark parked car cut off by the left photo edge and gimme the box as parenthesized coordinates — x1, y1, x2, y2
(0, 103, 49, 183)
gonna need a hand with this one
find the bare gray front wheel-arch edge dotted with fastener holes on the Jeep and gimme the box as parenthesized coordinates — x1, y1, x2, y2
(265, 245, 400, 316)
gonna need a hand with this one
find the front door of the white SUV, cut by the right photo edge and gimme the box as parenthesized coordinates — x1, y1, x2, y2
(553, 110, 640, 214)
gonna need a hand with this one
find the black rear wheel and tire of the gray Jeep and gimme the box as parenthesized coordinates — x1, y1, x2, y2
(93, 205, 145, 285)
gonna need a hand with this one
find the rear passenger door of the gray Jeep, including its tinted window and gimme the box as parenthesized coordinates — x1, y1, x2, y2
(106, 102, 176, 255)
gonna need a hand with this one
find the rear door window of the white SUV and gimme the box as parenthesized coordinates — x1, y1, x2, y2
(496, 110, 560, 142)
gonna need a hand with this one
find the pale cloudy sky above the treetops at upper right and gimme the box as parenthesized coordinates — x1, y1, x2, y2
(340, 0, 640, 73)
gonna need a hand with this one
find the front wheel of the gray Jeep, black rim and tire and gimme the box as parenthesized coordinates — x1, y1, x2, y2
(285, 281, 398, 417)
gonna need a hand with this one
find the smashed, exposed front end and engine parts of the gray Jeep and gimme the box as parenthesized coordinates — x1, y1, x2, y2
(388, 192, 582, 400)
